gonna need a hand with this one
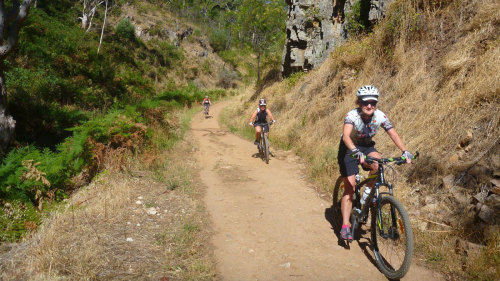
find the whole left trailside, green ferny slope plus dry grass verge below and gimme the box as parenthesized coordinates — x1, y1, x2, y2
(0, 0, 232, 280)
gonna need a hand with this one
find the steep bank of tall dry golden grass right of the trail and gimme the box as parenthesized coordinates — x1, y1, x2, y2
(228, 0, 500, 279)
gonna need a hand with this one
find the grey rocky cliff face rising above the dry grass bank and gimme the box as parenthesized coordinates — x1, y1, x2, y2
(282, 0, 393, 77)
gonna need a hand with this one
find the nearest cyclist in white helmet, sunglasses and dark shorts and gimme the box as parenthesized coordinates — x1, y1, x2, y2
(338, 85, 413, 241)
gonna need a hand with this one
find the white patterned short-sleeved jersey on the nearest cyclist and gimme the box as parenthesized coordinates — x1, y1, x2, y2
(344, 108, 392, 145)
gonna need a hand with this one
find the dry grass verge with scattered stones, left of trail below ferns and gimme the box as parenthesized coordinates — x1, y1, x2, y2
(0, 135, 215, 280)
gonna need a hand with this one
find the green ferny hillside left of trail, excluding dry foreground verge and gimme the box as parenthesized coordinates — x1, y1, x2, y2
(0, 0, 236, 243)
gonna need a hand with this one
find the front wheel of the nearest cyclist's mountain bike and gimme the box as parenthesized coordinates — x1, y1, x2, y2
(371, 195, 413, 279)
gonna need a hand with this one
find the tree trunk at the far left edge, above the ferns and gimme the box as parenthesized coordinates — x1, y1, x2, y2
(0, 0, 33, 151)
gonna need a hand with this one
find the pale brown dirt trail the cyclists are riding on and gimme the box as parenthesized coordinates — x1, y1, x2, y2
(192, 102, 440, 280)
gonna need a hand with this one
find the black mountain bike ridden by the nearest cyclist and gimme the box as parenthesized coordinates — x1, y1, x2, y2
(334, 152, 419, 279)
